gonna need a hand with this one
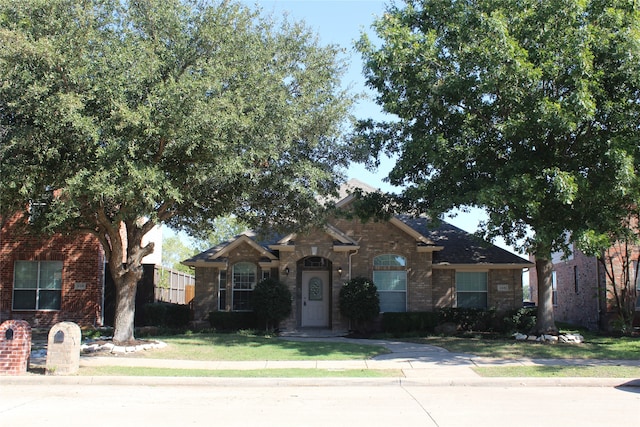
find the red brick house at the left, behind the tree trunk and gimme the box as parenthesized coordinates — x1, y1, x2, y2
(0, 215, 171, 327)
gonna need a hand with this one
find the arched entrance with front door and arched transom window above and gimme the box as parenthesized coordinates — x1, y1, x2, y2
(298, 256, 332, 328)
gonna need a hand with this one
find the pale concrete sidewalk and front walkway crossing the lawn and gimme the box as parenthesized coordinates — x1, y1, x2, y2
(21, 336, 640, 387)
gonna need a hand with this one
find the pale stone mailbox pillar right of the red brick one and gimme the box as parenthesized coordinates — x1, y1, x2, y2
(46, 322, 82, 375)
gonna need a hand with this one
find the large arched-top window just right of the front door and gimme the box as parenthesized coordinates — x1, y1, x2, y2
(373, 254, 407, 313)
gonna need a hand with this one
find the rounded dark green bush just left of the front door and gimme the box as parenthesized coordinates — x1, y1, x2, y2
(252, 278, 292, 331)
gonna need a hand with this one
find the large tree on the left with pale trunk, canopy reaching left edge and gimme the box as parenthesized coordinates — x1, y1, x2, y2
(0, 0, 351, 342)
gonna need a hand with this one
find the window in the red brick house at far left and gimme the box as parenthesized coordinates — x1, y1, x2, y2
(13, 261, 62, 310)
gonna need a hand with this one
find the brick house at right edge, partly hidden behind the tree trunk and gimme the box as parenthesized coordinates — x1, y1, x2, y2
(529, 245, 640, 330)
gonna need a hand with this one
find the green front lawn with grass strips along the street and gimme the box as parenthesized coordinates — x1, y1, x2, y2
(80, 333, 640, 378)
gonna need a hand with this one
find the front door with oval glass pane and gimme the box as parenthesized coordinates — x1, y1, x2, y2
(302, 271, 329, 328)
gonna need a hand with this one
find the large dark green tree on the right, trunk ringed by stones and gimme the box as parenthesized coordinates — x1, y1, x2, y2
(358, 0, 640, 333)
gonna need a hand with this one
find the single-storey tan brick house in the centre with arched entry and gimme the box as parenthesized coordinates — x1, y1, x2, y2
(183, 181, 532, 330)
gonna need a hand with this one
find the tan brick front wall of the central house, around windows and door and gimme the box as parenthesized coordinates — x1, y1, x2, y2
(185, 214, 526, 330)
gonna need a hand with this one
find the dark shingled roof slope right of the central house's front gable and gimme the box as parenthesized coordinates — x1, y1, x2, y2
(397, 215, 530, 265)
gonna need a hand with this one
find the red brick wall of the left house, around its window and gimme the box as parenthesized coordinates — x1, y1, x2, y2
(0, 213, 104, 327)
